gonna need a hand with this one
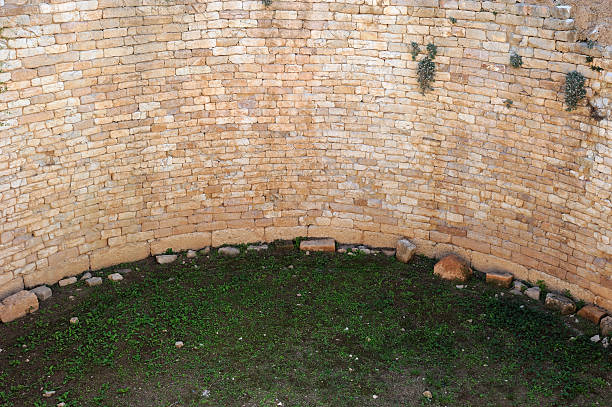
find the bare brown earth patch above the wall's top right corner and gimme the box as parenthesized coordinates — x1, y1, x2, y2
(531, 0, 612, 45)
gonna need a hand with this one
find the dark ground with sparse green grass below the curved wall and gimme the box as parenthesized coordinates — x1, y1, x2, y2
(0, 242, 612, 407)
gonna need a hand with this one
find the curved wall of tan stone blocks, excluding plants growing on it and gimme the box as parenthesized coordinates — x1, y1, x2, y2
(0, 0, 612, 309)
